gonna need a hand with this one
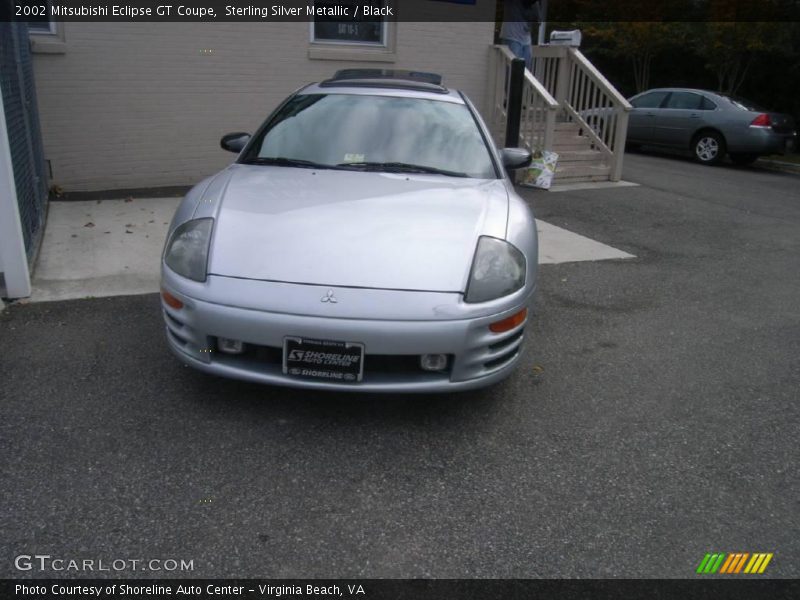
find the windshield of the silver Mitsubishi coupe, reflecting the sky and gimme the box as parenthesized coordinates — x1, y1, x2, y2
(242, 94, 497, 179)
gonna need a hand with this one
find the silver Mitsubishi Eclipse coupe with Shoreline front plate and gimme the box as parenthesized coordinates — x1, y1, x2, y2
(161, 69, 538, 392)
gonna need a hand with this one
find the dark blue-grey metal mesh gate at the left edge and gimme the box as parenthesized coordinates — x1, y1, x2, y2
(0, 19, 47, 264)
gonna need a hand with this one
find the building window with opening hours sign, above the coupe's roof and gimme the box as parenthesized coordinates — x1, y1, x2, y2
(311, 0, 387, 46)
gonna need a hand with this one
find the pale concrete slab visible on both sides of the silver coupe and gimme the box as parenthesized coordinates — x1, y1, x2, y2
(29, 198, 633, 302)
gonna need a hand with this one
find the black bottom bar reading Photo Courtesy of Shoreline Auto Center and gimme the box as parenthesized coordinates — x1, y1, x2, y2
(0, 577, 800, 600)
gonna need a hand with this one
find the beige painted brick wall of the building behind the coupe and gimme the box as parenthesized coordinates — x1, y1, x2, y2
(34, 22, 494, 191)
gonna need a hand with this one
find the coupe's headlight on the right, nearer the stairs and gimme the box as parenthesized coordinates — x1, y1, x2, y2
(465, 236, 525, 302)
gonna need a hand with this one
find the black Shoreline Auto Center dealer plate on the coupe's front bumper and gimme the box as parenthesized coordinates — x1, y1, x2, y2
(283, 337, 364, 383)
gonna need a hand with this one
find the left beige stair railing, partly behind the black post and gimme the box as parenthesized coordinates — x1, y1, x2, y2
(487, 46, 558, 152)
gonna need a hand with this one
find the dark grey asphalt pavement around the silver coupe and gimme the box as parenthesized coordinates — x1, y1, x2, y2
(0, 154, 800, 578)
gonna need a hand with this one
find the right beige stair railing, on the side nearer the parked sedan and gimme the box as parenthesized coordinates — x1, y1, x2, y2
(533, 46, 631, 181)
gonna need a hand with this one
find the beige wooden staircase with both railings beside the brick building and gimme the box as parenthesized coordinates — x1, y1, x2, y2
(488, 46, 631, 185)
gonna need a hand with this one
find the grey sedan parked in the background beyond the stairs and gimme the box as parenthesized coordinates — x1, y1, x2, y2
(627, 88, 796, 165)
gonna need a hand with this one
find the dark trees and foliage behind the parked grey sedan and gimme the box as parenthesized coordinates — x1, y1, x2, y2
(551, 18, 800, 122)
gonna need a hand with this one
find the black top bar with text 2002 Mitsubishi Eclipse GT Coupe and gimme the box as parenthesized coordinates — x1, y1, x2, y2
(0, 0, 800, 23)
